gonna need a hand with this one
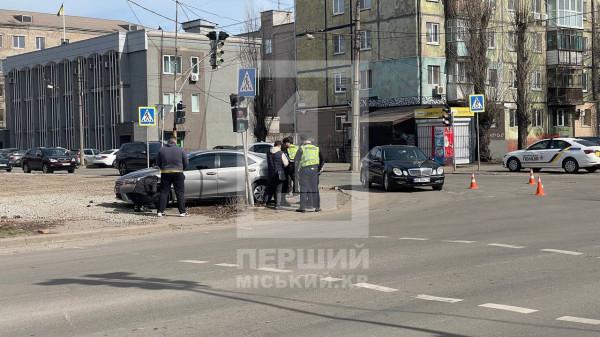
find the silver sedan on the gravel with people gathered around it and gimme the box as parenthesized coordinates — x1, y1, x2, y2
(115, 150, 267, 202)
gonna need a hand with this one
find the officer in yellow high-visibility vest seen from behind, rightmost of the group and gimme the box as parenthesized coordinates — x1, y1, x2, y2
(294, 135, 325, 212)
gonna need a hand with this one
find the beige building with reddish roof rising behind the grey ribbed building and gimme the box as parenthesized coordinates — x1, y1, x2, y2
(0, 9, 137, 142)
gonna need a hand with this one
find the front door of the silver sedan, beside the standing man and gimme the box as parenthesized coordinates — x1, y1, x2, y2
(183, 153, 217, 200)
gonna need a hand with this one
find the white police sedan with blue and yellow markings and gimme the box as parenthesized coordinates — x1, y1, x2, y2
(502, 138, 600, 173)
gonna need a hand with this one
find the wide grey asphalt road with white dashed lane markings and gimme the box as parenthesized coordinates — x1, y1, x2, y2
(0, 171, 600, 337)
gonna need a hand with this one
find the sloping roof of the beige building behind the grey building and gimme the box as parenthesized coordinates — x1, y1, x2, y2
(0, 9, 137, 32)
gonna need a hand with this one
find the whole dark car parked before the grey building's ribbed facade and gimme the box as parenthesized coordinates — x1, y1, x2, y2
(23, 147, 77, 173)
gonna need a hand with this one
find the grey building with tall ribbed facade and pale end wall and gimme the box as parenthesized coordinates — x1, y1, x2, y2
(3, 24, 258, 150)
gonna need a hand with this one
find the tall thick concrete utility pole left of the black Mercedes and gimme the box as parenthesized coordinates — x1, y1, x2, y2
(350, 0, 360, 173)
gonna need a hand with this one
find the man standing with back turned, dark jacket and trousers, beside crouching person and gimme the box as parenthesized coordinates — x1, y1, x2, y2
(156, 136, 189, 217)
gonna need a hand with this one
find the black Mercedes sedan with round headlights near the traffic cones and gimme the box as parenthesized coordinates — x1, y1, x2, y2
(360, 145, 445, 191)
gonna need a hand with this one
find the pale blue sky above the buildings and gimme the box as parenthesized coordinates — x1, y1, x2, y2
(0, 0, 294, 34)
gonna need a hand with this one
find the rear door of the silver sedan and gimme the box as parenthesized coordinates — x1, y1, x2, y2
(217, 153, 247, 197)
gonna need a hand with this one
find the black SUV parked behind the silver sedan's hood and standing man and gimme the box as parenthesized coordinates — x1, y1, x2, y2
(115, 142, 161, 175)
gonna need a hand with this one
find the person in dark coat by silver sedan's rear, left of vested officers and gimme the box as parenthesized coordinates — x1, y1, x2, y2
(264, 140, 291, 208)
